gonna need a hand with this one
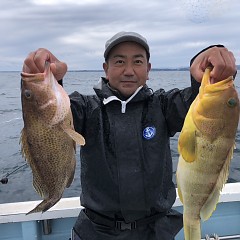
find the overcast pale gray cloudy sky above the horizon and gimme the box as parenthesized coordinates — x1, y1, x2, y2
(0, 0, 240, 71)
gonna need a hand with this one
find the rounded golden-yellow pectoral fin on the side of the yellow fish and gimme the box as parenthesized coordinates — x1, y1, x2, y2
(178, 129, 196, 162)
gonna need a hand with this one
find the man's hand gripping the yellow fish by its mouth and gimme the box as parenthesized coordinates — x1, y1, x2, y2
(190, 47, 237, 83)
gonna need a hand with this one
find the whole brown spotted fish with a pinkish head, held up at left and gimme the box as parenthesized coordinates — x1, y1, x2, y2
(20, 63, 85, 214)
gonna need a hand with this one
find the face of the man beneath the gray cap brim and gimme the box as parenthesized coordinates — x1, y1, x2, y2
(103, 42, 151, 97)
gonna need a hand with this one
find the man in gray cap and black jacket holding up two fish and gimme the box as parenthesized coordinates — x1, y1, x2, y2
(23, 32, 236, 240)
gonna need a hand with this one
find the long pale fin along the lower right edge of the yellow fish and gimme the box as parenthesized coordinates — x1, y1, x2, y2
(200, 146, 234, 221)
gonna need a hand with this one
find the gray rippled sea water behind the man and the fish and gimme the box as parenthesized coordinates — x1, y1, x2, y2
(0, 71, 240, 203)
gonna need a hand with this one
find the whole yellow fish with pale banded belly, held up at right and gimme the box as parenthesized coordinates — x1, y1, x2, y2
(177, 68, 239, 240)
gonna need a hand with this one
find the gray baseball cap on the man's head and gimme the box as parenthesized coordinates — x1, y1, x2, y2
(104, 32, 150, 59)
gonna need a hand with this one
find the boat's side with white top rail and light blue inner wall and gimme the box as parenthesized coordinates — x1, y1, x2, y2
(0, 183, 240, 240)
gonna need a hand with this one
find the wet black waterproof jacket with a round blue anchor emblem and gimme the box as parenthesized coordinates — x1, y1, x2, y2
(70, 75, 199, 222)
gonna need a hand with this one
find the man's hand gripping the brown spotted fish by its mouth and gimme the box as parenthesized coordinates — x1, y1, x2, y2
(22, 48, 67, 80)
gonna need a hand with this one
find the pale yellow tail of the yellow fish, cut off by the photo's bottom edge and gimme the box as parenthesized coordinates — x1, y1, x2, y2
(183, 216, 201, 240)
